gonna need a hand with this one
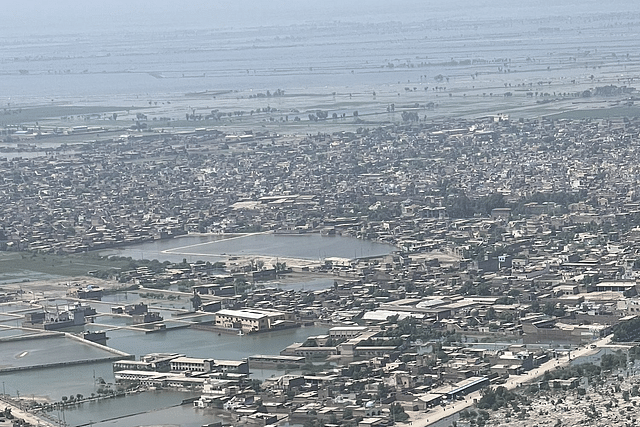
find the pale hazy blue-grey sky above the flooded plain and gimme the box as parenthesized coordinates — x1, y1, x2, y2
(0, 0, 640, 37)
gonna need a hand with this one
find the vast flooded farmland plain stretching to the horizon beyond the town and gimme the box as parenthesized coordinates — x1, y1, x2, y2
(0, 5, 640, 135)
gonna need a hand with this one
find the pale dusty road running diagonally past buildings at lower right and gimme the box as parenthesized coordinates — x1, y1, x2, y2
(407, 335, 613, 427)
